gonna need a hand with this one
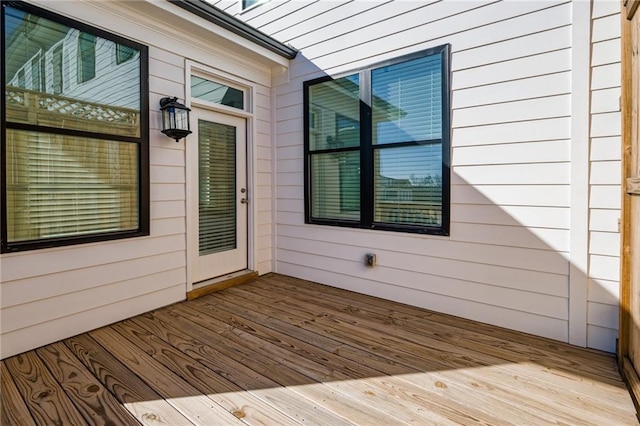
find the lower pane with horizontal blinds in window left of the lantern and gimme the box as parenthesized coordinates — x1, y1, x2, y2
(6, 129, 139, 242)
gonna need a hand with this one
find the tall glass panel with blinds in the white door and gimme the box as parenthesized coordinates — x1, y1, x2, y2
(198, 120, 237, 256)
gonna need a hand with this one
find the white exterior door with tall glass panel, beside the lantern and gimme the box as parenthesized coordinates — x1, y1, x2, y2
(187, 109, 249, 284)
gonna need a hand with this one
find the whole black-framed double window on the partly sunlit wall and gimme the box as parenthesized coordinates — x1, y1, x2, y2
(304, 45, 450, 235)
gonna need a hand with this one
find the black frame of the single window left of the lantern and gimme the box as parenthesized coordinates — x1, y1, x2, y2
(0, 0, 150, 253)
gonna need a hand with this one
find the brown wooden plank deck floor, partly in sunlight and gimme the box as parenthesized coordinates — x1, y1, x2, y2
(0, 274, 638, 426)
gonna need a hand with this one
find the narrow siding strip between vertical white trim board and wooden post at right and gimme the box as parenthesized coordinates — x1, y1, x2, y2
(587, 0, 621, 352)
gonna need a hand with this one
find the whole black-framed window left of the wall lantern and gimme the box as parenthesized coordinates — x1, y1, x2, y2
(1, 2, 149, 252)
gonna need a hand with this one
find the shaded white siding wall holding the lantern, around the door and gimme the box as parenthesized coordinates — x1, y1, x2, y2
(0, 2, 272, 358)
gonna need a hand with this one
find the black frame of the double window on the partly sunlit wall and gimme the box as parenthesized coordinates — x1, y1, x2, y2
(303, 44, 451, 236)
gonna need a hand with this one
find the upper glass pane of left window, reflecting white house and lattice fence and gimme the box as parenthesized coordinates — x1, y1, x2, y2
(4, 7, 141, 136)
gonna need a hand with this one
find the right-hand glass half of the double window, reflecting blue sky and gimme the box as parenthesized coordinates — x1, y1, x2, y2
(371, 55, 442, 226)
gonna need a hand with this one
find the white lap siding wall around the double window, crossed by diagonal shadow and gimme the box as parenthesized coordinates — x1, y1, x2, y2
(224, 1, 619, 351)
